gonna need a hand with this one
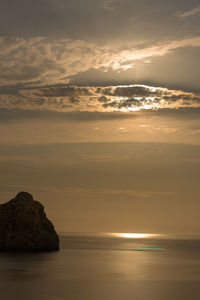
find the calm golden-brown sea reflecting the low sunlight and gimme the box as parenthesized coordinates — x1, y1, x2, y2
(0, 233, 200, 300)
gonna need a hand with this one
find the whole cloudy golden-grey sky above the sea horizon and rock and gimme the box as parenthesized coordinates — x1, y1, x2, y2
(0, 0, 200, 234)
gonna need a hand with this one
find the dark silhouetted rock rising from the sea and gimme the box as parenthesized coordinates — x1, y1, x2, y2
(0, 192, 59, 251)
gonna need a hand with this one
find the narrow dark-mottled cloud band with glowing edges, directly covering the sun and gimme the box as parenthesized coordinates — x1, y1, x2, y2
(0, 85, 200, 113)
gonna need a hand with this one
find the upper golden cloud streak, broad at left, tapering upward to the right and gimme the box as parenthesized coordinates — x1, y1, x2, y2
(0, 36, 200, 86)
